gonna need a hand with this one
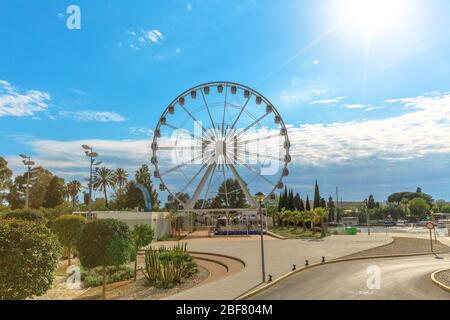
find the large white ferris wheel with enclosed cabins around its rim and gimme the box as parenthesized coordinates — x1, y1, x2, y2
(151, 82, 291, 210)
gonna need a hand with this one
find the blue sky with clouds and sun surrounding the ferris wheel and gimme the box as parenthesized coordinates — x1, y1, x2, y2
(0, 0, 450, 200)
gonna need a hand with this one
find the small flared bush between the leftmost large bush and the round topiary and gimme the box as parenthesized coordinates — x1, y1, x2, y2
(51, 214, 87, 266)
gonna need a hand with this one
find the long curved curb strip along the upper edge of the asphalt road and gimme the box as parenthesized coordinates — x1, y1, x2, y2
(235, 245, 450, 300)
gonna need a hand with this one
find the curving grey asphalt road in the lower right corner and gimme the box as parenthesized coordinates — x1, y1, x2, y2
(251, 254, 450, 300)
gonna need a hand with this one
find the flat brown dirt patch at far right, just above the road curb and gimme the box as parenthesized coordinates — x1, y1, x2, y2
(344, 237, 450, 258)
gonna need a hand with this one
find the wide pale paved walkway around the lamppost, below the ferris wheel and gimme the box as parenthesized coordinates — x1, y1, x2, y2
(158, 234, 392, 300)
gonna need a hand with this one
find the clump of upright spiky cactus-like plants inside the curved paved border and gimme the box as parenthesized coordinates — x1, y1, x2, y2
(144, 243, 197, 288)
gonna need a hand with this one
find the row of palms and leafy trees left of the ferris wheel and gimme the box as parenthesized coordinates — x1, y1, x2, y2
(0, 157, 160, 210)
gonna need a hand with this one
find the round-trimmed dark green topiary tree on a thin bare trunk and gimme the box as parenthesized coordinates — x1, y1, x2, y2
(76, 219, 136, 299)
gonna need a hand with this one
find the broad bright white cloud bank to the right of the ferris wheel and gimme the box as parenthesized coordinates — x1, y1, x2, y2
(289, 94, 450, 166)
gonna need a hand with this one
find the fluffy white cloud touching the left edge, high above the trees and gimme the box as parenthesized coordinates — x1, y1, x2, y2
(0, 80, 51, 117)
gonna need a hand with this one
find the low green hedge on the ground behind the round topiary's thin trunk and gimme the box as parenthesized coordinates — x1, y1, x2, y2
(81, 265, 133, 288)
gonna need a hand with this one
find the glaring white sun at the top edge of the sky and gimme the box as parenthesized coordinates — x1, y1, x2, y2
(338, 0, 406, 33)
